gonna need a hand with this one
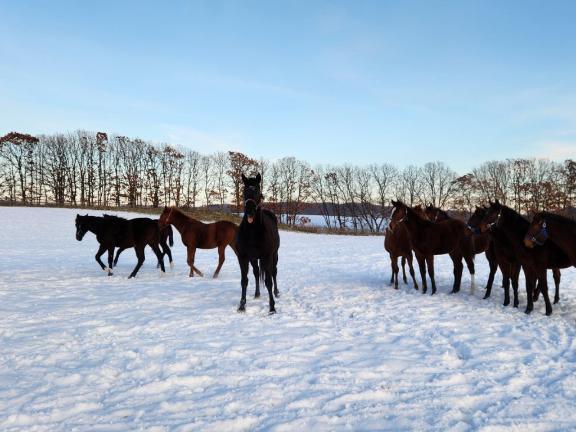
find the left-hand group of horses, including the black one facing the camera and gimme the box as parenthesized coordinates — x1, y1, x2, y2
(76, 174, 280, 314)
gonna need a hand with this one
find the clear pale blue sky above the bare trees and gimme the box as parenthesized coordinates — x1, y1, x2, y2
(0, 0, 576, 172)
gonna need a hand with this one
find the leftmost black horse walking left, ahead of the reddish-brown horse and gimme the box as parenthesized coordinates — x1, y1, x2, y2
(76, 214, 165, 278)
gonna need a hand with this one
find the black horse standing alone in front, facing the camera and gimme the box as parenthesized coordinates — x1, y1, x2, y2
(236, 174, 280, 314)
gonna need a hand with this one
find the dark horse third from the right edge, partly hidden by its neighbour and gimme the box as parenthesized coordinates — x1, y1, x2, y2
(466, 207, 521, 307)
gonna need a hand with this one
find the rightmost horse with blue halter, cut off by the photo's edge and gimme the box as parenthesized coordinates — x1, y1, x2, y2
(524, 212, 576, 267)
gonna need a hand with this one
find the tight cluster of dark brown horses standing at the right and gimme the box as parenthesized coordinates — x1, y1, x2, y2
(384, 200, 576, 315)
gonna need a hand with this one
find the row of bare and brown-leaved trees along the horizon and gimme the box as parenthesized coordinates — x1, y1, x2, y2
(0, 131, 576, 232)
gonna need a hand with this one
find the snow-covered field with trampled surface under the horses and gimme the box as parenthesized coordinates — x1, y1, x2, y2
(0, 208, 576, 431)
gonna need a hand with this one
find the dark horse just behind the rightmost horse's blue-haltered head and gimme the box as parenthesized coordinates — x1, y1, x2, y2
(480, 200, 571, 315)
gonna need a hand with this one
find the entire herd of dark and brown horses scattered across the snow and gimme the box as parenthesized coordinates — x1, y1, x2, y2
(76, 174, 576, 315)
